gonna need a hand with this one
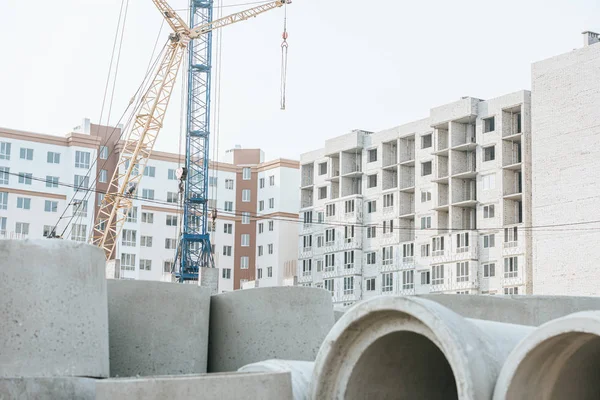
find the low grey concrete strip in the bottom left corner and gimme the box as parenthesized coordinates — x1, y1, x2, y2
(0, 377, 96, 400)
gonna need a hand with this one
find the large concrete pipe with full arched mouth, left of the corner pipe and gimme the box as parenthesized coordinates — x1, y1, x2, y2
(311, 296, 534, 400)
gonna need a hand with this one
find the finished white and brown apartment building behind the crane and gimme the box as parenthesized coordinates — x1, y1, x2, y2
(0, 119, 299, 292)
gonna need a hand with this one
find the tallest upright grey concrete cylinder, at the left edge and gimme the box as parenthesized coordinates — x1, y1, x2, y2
(0, 239, 108, 378)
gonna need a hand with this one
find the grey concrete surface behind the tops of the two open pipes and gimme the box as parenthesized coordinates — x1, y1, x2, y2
(418, 294, 600, 326)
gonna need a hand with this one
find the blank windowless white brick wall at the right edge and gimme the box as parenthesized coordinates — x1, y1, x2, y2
(531, 32, 600, 296)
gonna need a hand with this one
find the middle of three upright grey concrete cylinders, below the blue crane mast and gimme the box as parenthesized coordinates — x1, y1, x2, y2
(108, 280, 210, 376)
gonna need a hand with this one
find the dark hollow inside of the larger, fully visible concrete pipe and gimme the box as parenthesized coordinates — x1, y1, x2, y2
(345, 332, 458, 400)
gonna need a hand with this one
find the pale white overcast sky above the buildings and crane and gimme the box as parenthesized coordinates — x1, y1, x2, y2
(0, 0, 600, 160)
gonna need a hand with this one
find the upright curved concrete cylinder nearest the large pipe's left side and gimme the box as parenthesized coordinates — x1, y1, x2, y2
(208, 286, 334, 372)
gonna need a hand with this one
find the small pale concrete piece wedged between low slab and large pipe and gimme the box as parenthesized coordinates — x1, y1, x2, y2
(238, 360, 315, 400)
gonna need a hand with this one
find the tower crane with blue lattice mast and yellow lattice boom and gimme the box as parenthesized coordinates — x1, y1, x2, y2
(90, 0, 291, 281)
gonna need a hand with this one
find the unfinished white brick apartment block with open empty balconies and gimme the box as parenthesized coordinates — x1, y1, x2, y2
(298, 91, 532, 304)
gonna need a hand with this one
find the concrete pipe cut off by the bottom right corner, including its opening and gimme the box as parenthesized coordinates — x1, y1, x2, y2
(494, 311, 600, 400)
